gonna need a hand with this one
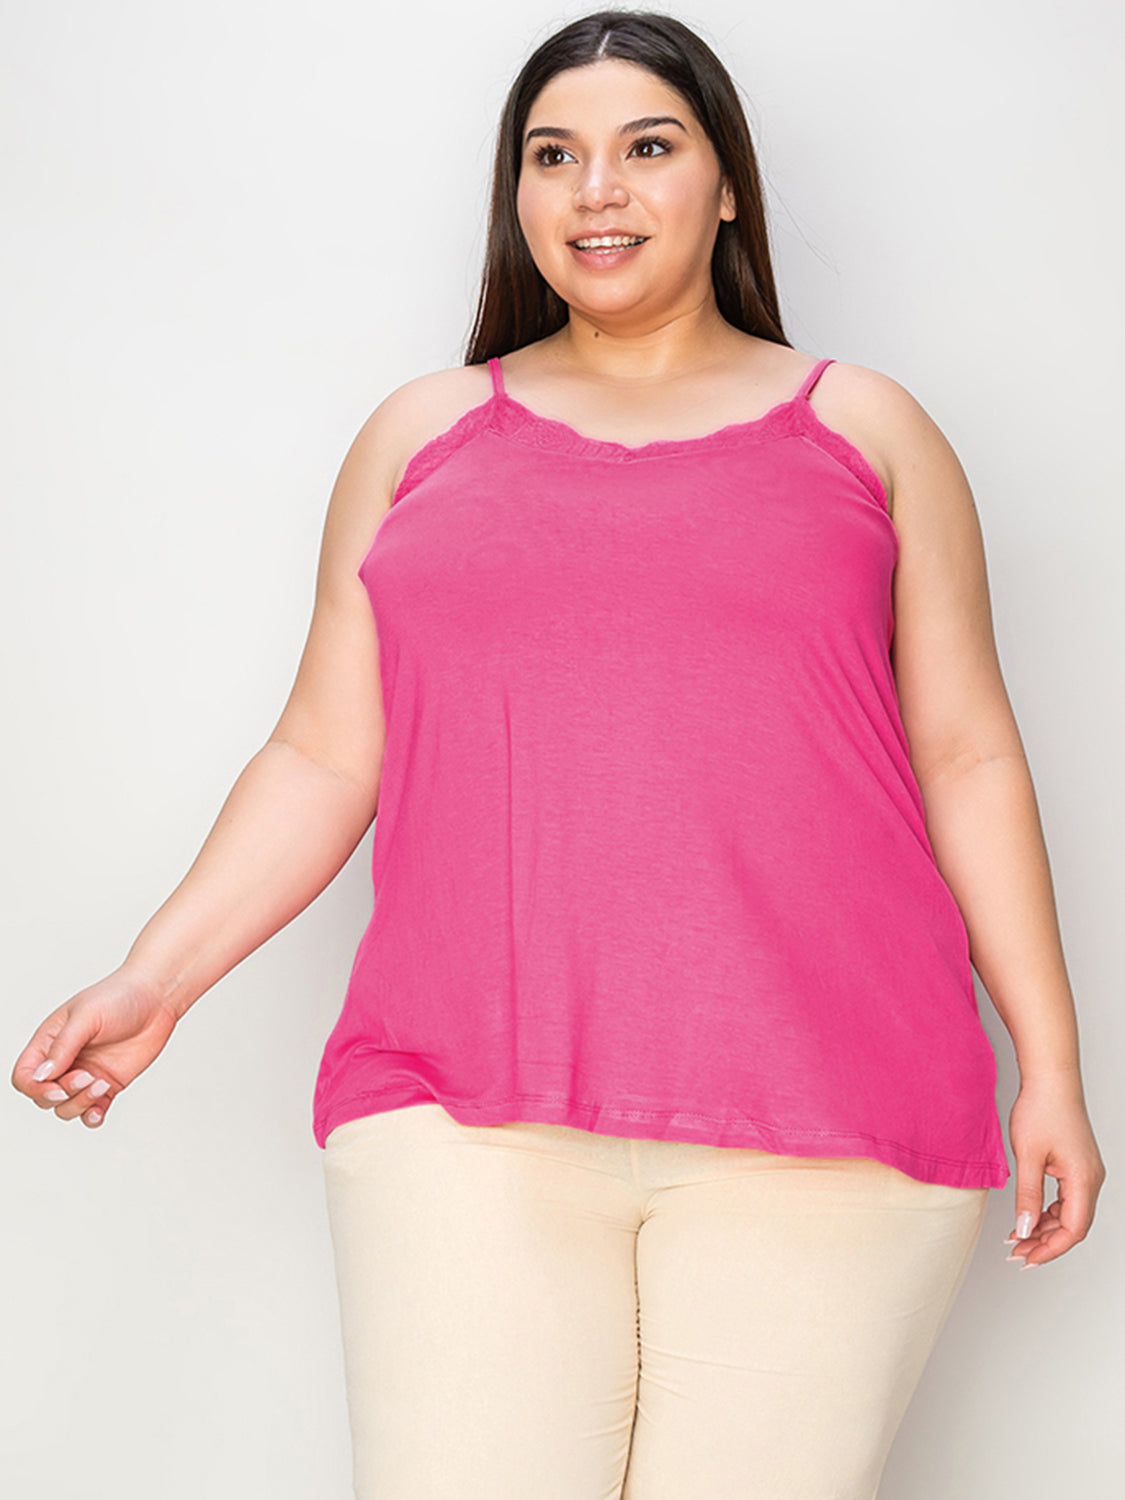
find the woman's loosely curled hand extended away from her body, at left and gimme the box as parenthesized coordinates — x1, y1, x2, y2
(12, 966, 179, 1127)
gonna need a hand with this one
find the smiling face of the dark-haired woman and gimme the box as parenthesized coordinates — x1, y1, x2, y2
(516, 59, 735, 324)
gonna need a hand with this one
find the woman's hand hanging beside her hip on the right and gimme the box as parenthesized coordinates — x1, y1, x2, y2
(1008, 1073, 1106, 1269)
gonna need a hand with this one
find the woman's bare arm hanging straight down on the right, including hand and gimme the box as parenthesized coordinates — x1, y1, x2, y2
(861, 371, 1106, 1266)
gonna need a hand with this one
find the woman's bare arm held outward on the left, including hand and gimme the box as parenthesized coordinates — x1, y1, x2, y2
(12, 389, 417, 1124)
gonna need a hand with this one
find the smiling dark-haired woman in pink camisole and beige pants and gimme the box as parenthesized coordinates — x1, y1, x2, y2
(14, 11, 1106, 1500)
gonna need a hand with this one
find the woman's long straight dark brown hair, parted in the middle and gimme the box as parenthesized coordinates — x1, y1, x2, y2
(465, 11, 792, 365)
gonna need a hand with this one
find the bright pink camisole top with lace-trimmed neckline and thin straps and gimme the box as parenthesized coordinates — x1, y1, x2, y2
(314, 360, 1010, 1188)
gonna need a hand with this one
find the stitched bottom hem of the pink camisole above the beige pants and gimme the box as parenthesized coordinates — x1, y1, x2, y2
(314, 1088, 1011, 1188)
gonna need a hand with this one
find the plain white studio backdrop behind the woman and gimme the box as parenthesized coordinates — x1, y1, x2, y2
(0, 0, 1125, 1500)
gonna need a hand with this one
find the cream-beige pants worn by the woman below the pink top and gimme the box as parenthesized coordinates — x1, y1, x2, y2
(324, 1104, 989, 1500)
